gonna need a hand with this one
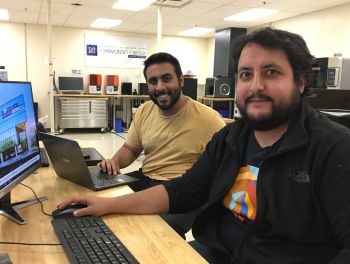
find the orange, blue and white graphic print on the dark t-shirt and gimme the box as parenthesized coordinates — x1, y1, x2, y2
(223, 165, 259, 223)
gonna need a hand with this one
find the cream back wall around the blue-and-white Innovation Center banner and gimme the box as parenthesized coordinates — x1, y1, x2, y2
(0, 22, 213, 127)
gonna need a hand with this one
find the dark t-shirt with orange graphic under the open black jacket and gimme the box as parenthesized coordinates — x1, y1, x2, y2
(219, 132, 281, 250)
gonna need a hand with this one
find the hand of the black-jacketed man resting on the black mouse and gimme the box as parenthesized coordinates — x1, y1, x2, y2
(57, 196, 112, 216)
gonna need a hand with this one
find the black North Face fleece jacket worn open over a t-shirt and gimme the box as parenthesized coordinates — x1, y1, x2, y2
(164, 102, 350, 264)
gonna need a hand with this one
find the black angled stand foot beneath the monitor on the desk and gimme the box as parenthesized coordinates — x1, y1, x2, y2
(0, 193, 47, 225)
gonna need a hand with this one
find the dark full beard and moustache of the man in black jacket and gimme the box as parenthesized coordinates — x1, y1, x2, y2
(237, 87, 301, 131)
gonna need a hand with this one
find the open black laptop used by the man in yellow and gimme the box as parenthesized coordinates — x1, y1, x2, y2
(40, 134, 138, 191)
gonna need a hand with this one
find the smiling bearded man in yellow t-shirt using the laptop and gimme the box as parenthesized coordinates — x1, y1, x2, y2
(97, 52, 225, 236)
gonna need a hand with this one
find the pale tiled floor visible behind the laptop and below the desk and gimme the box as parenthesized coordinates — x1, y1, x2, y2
(55, 131, 193, 241)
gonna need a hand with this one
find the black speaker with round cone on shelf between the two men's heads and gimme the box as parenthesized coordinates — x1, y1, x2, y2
(205, 77, 235, 98)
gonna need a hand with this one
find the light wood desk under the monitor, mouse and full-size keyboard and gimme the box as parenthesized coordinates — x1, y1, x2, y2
(0, 167, 206, 264)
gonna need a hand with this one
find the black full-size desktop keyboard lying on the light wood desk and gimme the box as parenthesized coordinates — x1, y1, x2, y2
(51, 216, 139, 264)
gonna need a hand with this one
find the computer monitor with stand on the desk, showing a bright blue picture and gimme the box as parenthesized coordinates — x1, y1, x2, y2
(0, 82, 47, 224)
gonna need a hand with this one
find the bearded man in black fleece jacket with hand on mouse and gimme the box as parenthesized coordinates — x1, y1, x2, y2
(59, 28, 350, 264)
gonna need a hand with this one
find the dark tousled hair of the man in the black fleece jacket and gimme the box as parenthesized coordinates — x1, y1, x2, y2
(232, 27, 315, 95)
